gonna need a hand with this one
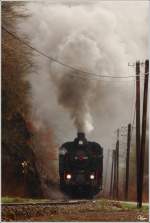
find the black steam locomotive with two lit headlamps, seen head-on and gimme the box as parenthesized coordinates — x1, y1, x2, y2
(59, 133, 103, 198)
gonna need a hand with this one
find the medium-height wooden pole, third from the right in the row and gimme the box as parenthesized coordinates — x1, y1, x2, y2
(125, 124, 131, 201)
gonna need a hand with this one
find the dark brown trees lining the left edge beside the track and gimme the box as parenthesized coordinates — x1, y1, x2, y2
(1, 2, 42, 197)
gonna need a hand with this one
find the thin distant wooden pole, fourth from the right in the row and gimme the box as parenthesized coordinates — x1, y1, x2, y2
(116, 129, 119, 199)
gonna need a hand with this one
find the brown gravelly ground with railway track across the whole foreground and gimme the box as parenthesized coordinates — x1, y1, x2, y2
(2, 199, 148, 222)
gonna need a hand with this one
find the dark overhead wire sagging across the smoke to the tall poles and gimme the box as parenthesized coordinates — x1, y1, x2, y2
(2, 26, 147, 79)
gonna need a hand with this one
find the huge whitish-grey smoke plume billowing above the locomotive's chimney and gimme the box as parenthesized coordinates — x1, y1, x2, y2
(12, 1, 148, 197)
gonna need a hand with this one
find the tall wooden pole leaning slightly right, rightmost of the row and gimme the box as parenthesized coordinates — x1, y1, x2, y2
(139, 60, 149, 208)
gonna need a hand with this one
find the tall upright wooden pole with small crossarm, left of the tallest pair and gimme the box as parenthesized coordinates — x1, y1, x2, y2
(136, 61, 140, 208)
